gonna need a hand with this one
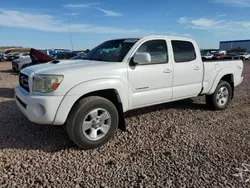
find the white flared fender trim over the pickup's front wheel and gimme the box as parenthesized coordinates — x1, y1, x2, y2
(52, 78, 129, 125)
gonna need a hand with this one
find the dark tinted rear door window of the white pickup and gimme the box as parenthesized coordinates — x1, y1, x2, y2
(171, 40, 196, 63)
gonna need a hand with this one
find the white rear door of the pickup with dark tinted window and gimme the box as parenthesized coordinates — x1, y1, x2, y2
(171, 40, 203, 99)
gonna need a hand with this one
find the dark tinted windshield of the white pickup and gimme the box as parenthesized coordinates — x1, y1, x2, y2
(84, 38, 139, 62)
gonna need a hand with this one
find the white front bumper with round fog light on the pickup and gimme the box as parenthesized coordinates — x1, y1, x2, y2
(15, 86, 63, 124)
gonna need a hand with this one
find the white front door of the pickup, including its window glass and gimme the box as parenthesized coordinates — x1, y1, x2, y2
(128, 39, 173, 108)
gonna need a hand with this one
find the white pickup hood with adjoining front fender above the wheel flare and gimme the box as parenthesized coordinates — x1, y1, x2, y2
(21, 60, 127, 95)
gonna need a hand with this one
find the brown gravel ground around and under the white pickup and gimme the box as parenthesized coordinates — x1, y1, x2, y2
(0, 61, 250, 188)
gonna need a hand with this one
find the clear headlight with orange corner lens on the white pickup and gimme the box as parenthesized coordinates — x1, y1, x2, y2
(32, 74, 63, 93)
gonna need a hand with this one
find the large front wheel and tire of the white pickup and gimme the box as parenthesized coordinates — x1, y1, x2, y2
(66, 96, 119, 150)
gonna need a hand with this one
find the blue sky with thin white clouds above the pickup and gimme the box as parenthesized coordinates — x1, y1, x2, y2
(0, 0, 250, 50)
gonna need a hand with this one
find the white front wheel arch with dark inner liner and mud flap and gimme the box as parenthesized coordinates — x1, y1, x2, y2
(53, 80, 128, 130)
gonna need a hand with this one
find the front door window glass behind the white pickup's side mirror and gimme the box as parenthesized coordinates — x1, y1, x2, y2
(136, 40, 168, 63)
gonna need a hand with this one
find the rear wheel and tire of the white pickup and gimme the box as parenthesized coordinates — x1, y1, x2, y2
(206, 80, 232, 110)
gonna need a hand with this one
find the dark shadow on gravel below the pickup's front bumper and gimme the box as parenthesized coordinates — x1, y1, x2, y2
(0, 100, 77, 152)
